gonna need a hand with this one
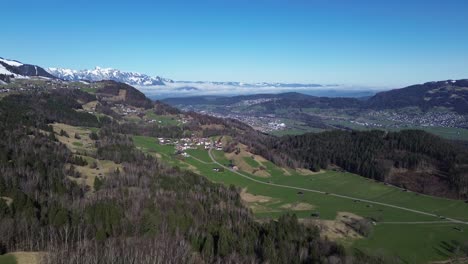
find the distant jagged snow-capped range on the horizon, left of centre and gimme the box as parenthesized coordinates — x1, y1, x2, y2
(47, 67, 173, 86)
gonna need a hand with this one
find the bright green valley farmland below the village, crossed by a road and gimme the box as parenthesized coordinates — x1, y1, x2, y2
(134, 137, 468, 263)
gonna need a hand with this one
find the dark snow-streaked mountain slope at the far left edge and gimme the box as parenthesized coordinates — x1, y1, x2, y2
(0, 57, 55, 78)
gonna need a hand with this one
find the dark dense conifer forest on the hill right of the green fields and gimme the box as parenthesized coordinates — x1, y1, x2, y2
(250, 130, 468, 198)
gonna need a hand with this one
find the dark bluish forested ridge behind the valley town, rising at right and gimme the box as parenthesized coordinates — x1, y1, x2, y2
(163, 80, 468, 114)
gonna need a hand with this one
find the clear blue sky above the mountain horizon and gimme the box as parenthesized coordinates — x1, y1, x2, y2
(0, 0, 468, 87)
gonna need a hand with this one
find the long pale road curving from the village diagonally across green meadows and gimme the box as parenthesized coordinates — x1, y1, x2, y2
(208, 148, 468, 225)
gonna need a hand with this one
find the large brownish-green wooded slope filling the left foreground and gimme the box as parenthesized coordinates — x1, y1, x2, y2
(0, 89, 354, 263)
